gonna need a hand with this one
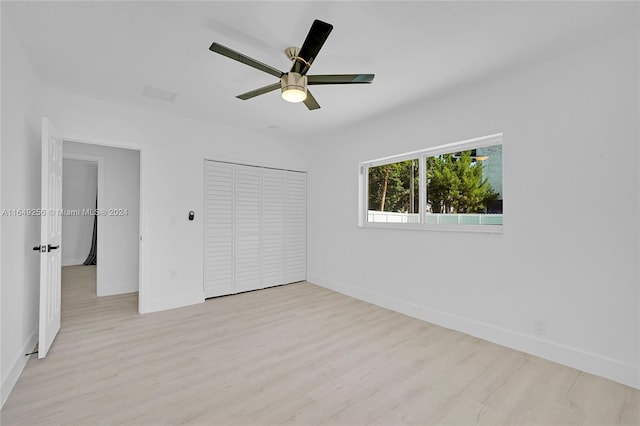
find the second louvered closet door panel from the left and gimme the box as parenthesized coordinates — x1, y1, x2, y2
(235, 165, 262, 292)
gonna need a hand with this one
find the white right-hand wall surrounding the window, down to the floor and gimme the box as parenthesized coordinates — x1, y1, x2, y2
(308, 31, 640, 387)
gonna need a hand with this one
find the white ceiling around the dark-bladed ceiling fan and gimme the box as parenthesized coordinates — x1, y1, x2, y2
(2, 1, 636, 135)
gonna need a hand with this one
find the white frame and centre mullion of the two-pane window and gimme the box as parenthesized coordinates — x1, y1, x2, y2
(358, 133, 504, 234)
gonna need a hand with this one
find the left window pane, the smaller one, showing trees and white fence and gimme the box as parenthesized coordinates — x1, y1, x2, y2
(367, 159, 420, 223)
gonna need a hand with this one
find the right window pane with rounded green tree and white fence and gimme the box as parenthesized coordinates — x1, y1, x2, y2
(425, 145, 503, 225)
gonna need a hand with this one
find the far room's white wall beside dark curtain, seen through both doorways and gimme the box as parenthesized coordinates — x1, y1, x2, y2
(60, 159, 97, 266)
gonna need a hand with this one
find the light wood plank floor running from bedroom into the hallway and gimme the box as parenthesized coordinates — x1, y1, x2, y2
(1, 267, 640, 425)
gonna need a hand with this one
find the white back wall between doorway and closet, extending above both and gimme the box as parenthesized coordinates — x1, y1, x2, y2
(43, 89, 306, 313)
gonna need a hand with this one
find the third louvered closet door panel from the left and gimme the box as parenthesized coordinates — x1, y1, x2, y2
(262, 169, 286, 287)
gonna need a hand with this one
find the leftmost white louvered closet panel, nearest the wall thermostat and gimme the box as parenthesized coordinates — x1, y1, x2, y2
(204, 161, 235, 297)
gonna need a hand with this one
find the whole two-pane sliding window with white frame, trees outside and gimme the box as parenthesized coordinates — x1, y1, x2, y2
(360, 134, 503, 232)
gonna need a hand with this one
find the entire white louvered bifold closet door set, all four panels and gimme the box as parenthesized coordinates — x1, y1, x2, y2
(204, 161, 307, 298)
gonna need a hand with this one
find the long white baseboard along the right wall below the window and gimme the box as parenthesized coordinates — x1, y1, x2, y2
(307, 274, 640, 389)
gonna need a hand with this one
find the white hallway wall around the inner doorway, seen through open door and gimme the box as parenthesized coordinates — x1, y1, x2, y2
(59, 141, 140, 296)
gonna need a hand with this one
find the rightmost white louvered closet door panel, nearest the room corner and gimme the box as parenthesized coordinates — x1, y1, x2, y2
(285, 172, 307, 283)
